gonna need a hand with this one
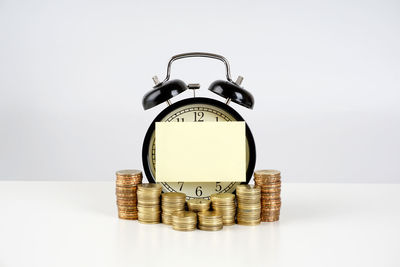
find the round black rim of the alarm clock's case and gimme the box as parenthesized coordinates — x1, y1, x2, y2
(142, 97, 256, 187)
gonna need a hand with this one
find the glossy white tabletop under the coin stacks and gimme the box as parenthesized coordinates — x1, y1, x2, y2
(0, 182, 400, 267)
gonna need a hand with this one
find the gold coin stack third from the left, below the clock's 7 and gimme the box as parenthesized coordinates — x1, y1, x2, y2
(161, 192, 186, 224)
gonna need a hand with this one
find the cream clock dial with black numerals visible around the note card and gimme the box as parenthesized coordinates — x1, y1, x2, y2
(148, 103, 249, 198)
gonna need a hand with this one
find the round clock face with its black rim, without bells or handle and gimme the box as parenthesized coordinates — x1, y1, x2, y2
(143, 98, 255, 199)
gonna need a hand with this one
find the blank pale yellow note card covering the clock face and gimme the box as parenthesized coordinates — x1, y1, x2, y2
(155, 122, 246, 182)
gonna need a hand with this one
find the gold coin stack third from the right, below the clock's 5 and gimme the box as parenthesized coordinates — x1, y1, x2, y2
(211, 193, 236, 226)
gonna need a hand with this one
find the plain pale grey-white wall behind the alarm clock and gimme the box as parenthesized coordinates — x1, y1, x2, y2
(0, 0, 400, 182)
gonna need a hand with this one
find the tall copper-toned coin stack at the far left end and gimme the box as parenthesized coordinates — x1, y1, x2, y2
(116, 170, 142, 220)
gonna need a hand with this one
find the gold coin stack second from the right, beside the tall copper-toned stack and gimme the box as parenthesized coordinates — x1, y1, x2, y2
(236, 185, 261, 225)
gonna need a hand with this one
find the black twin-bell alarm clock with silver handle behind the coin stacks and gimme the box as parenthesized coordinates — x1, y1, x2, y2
(142, 52, 256, 199)
